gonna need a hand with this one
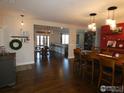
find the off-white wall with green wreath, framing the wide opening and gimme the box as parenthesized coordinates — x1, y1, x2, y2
(3, 16, 82, 65)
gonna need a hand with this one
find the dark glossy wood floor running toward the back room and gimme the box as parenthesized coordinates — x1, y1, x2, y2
(0, 54, 96, 93)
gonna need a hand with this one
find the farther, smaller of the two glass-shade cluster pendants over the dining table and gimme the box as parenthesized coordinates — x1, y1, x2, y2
(88, 13, 96, 32)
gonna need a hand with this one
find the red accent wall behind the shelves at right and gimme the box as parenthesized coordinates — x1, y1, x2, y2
(100, 23, 124, 52)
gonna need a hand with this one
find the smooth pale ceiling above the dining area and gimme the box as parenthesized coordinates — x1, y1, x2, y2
(0, 0, 124, 26)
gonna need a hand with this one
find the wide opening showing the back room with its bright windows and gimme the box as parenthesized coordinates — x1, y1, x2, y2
(34, 25, 69, 61)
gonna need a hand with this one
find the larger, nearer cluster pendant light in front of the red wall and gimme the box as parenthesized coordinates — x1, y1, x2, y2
(106, 6, 117, 31)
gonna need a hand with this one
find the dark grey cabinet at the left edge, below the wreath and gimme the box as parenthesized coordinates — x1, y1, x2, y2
(0, 53, 16, 87)
